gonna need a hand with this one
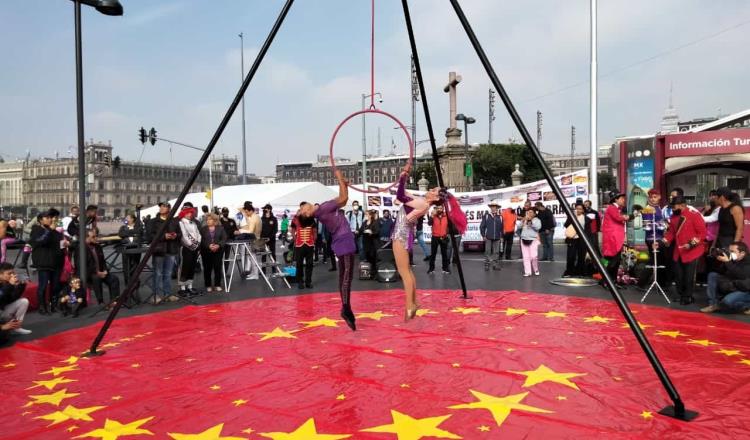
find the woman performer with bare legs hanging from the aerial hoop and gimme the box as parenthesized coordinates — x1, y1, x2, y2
(391, 165, 467, 321)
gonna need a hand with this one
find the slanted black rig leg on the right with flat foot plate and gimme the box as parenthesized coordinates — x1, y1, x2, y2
(450, 0, 698, 420)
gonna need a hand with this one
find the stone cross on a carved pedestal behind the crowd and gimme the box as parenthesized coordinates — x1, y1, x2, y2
(438, 72, 468, 191)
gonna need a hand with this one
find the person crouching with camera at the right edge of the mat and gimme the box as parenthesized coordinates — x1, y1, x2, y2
(701, 241, 750, 315)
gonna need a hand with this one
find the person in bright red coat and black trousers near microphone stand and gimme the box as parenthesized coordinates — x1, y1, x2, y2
(654, 196, 706, 305)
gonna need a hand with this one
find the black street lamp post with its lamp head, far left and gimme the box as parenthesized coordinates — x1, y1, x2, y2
(73, 0, 123, 296)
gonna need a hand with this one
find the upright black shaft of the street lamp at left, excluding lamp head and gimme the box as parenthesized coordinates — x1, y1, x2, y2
(73, 0, 87, 291)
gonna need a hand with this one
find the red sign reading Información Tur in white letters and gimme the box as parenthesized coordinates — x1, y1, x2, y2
(664, 128, 750, 157)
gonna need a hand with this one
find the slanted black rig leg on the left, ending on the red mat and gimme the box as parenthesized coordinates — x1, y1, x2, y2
(87, 0, 294, 356)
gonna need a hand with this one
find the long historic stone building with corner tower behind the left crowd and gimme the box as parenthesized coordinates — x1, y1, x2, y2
(22, 142, 239, 217)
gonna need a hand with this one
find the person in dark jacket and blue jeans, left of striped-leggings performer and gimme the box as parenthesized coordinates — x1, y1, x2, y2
(147, 202, 180, 299)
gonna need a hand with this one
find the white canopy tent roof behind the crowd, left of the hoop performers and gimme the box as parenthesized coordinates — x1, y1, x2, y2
(141, 182, 338, 217)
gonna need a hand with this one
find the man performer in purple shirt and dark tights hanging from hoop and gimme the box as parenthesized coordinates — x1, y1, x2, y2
(299, 170, 357, 330)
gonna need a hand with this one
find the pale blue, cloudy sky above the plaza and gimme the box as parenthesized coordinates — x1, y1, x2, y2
(0, 0, 750, 175)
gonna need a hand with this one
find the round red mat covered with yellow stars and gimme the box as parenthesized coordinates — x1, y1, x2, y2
(0, 290, 750, 440)
